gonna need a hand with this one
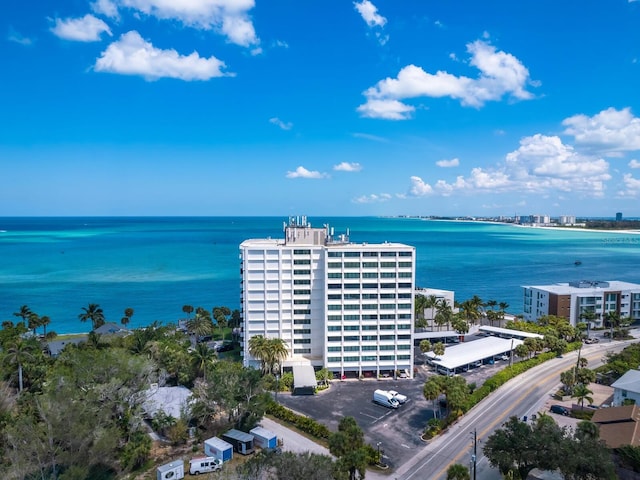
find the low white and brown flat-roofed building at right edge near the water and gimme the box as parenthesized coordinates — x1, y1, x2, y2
(523, 281, 640, 327)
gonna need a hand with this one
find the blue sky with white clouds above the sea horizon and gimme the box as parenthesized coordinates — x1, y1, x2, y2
(0, 0, 640, 217)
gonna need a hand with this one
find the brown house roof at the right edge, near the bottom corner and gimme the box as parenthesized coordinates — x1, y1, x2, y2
(591, 405, 640, 448)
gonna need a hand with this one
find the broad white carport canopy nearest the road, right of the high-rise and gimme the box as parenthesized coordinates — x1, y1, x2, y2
(427, 337, 524, 370)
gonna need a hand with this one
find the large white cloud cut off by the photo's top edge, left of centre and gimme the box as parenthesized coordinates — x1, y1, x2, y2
(113, 0, 260, 47)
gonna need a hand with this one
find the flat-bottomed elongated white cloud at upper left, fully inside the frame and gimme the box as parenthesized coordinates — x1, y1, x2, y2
(94, 31, 231, 81)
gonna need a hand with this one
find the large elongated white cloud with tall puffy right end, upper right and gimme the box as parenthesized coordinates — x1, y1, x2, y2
(358, 40, 533, 120)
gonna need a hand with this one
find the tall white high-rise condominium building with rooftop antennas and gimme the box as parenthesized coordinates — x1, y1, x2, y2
(240, 217, 416, 377)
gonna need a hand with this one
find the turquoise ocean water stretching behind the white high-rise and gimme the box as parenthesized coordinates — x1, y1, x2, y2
(0, 217, 640, 333)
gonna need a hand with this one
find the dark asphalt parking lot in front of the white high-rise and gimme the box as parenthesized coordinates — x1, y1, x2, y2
(278, 338, 520, 469)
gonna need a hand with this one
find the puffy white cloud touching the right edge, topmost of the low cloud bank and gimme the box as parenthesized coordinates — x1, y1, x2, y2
(562, 107, 640, 156)
